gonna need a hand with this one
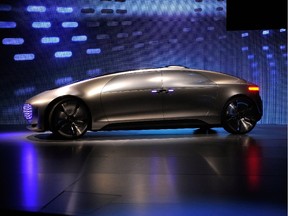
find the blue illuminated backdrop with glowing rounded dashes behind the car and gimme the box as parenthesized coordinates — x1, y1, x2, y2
(0, 0, 287, 124)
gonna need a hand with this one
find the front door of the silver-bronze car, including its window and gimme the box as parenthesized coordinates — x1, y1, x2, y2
(101, 71, 163, 123)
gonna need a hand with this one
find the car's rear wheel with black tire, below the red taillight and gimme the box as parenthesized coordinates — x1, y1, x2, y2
(222, 97, 257, 134)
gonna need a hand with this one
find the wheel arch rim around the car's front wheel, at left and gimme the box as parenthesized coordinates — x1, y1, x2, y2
(44, 95, 92, 130)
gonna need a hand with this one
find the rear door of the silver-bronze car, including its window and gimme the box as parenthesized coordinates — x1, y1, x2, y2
(162, 71, 217, 119)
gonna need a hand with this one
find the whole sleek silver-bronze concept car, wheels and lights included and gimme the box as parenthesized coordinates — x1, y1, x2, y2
(23, 66, 262, 138)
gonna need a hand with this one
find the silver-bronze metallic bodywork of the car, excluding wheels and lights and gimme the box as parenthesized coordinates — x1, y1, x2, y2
(25, 66, 262, 131)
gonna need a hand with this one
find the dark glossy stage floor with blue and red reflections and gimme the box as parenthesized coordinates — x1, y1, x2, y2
(0, 125, 287, 216)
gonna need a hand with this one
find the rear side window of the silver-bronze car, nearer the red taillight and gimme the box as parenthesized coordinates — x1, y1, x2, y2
(163, 71, 213, 88)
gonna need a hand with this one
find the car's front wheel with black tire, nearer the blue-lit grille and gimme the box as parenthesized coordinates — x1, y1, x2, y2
(49, 98, 90, 139)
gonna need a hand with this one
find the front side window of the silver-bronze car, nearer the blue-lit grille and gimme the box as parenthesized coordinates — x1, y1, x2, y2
(102, 71, 162, 93)
